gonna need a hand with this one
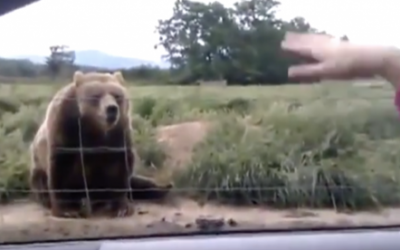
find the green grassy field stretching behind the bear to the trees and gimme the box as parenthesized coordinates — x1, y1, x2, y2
(0, 83, 400, 210)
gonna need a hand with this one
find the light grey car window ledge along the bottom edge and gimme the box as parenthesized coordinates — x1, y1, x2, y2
(0, 228, 400, 250)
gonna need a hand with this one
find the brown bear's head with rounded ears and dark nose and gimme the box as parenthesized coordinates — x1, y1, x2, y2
(73, 71, 130, 131)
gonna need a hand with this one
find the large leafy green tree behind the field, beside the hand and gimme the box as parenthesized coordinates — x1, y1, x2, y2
(157, 0, 322, 84)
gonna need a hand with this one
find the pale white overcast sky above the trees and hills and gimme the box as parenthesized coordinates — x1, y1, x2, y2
(0, 0, 400, 62)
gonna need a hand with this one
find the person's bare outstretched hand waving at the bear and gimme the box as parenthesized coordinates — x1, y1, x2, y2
(281, 32, 388, 81)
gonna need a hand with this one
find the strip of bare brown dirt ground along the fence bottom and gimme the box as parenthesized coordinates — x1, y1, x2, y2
(0, 200, 400, 242)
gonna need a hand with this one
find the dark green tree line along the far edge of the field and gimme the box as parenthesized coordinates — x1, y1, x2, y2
(0, 0, 348, 85)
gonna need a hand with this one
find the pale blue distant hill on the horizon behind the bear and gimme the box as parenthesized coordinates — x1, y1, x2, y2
(9, 50, 168, 69)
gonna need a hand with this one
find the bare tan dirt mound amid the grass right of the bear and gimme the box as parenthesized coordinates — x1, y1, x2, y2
(157, 121, 210, 169)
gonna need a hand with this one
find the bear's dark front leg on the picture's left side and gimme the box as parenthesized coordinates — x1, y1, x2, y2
(48, 149, 87, 218)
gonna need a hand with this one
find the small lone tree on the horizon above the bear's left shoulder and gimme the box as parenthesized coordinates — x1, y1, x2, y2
(46, 45, 75, 78)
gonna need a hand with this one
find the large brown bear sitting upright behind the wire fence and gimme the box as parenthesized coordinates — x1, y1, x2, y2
(30, 71, 172, 217)
